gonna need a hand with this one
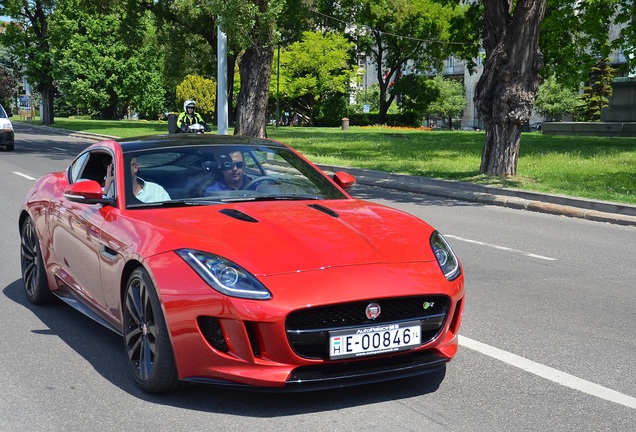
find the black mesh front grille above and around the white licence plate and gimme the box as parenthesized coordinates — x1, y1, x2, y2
(285, 296, 450, 360)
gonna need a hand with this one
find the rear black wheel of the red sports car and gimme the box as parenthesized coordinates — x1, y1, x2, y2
(20, 218, 54, 305)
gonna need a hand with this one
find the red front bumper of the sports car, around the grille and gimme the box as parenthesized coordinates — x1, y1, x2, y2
(149, 256, 464, 391)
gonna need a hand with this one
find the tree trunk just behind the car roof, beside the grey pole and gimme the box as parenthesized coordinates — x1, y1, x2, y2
(234, 46, 274, 138)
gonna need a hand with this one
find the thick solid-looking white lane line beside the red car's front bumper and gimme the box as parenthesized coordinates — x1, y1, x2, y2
(459, 335, 636, 409)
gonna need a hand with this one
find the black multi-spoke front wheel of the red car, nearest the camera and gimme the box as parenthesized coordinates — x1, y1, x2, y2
(124, 267, 181, 393)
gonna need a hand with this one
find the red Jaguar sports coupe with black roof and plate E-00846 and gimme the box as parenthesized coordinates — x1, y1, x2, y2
(19, 135, 464, 392)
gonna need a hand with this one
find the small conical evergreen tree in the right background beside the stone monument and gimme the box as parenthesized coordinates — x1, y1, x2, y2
(581, 59, 614, 122)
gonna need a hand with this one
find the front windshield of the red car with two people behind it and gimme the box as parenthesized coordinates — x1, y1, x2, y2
(124, 145, 347, 208)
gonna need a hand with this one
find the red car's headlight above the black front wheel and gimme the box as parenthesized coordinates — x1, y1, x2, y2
(176, 249, 272, 300)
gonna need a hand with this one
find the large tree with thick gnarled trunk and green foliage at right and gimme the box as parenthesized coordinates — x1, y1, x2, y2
(450, 0, 636, 175)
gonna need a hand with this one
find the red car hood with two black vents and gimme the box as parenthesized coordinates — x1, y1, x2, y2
(130, 200, 435, 275)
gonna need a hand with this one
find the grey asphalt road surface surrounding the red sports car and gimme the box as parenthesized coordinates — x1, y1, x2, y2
(0, 128, 636, 432)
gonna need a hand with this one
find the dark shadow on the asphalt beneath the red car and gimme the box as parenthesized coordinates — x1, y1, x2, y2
(2, 280, 446, 418)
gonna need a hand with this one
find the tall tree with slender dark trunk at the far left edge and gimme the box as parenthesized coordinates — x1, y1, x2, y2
(0, 0, 58, 125)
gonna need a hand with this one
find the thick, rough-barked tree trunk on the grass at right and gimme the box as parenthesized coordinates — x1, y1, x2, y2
(476, 0, 547, 176)
